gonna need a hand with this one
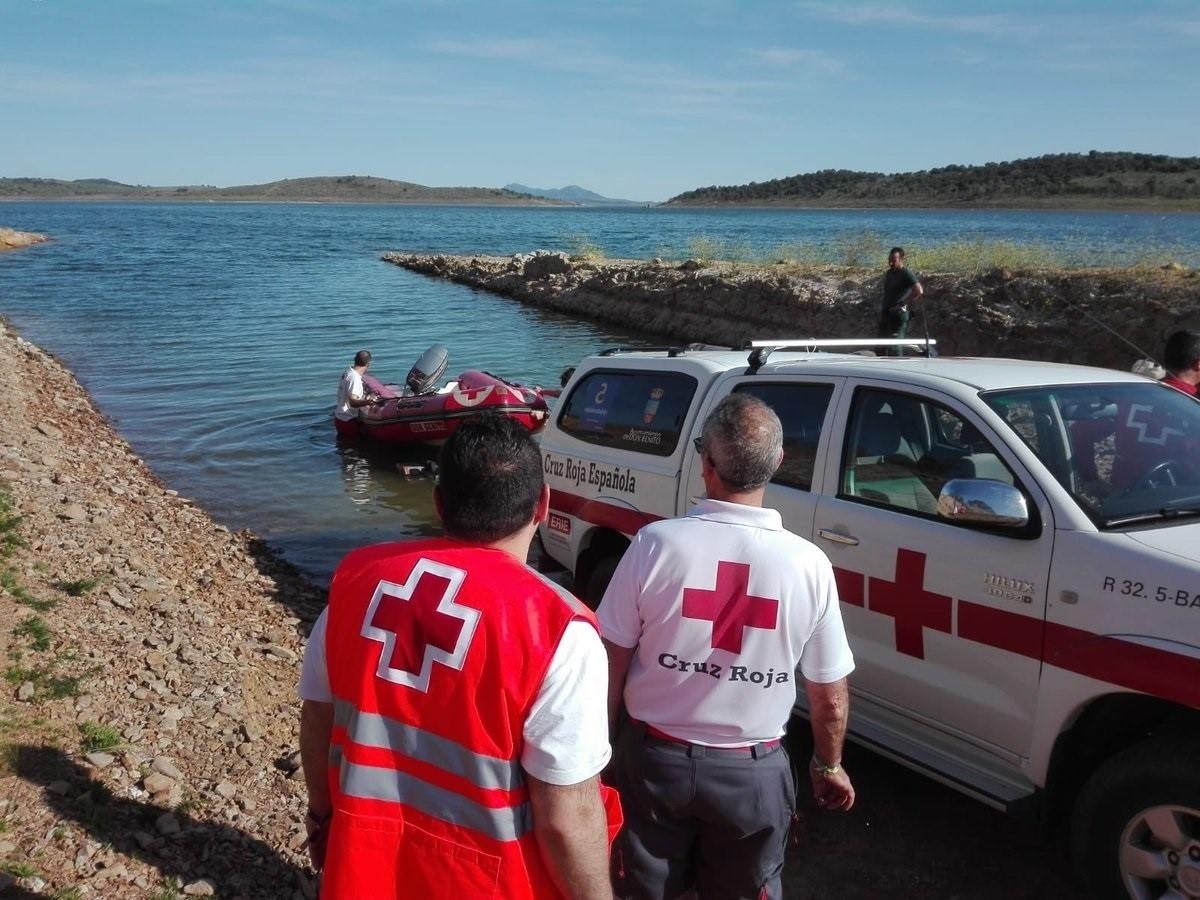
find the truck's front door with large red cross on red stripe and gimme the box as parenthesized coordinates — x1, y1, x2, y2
(815, 383, 1054, 758)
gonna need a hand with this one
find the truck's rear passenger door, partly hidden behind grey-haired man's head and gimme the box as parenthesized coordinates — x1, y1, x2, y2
(685, 376, 845, 540)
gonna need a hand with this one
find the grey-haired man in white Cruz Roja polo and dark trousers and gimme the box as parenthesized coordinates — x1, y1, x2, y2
(599, 394, 854, 900)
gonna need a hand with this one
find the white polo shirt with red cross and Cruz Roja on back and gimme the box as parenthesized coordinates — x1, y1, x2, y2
(599, 499, 854, 746)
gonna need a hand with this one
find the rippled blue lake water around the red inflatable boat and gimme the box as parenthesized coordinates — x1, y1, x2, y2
(0, 204, 1200, 577)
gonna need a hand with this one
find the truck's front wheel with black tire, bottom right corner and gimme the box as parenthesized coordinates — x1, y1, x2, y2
(1072, 737, 1200, 900)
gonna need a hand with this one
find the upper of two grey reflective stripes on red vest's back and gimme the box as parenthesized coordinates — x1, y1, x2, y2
(334, 698, 524, 791)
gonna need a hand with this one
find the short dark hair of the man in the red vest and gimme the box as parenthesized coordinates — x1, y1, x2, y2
(437, 413, 542, 544)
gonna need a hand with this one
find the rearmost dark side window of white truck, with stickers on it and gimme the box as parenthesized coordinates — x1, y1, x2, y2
(558, 370, 696, 456)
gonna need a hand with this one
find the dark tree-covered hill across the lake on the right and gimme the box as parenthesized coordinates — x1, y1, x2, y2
(666, 150, 1200, 210)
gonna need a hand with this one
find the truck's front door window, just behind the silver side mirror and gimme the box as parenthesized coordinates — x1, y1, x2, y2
(840, 389, 1015, 516)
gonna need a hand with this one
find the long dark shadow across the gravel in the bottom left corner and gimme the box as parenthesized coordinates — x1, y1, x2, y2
(12, 745, 312, 900)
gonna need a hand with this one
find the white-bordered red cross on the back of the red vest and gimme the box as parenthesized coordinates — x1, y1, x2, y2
(361, 559, 480, 692)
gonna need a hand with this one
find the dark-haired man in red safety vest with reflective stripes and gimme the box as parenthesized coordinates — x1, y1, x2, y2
(300, 416, 620, 900)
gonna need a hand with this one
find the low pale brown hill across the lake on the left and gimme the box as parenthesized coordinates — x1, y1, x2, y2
(0, 175, 554, 205)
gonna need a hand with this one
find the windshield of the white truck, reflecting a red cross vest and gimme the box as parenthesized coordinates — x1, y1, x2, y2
(983, 383, 1200, 528)
